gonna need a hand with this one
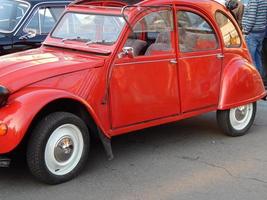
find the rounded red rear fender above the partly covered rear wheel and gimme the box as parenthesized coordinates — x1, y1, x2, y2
(218, 58, 266, 110)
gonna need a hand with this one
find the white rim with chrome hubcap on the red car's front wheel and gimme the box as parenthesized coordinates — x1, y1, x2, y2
(45, 124, 84, 175)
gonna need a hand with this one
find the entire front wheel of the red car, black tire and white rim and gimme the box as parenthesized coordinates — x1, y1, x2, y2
(27, 112, 90, 184)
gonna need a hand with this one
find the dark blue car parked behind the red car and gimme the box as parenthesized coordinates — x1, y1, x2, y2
(0, 0, 70, 55)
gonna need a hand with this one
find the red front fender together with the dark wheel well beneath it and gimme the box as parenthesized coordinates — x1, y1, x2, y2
(0, 89, 108, 154)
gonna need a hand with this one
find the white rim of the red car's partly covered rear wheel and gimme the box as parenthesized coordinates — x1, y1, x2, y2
(229, 103, 253, 130)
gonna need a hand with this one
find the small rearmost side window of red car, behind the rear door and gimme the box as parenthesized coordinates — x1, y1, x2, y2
(215, 11, 241, 48)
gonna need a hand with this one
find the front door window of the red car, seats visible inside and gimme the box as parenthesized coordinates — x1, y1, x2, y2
(124, 10, 174, 56)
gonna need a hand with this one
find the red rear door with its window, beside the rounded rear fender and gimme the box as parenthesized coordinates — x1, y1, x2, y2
(176, 8, 223, 113)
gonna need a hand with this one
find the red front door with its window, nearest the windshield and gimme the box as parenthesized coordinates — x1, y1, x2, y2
(110, 8, 180, 129)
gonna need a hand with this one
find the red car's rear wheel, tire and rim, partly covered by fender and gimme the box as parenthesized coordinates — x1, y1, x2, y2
(217, 102, 257, 137)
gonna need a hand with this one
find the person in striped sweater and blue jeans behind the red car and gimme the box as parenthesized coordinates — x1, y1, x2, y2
(242, 0, 267, 79)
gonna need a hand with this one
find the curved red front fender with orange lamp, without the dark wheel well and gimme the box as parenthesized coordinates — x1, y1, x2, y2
(0, 88, 105, 154)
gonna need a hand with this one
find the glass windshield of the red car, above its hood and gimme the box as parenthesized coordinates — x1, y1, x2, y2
(52, 12, 125, 45)
